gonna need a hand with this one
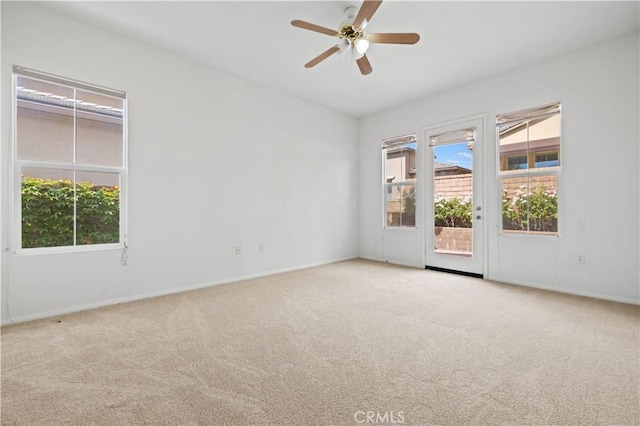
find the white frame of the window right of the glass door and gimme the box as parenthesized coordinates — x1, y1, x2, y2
(496, 102, 563, 238)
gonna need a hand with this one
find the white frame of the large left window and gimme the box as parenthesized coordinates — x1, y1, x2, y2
(10, 65, 129, 255)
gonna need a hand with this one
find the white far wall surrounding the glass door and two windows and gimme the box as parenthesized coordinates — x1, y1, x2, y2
(359, 33, 640, 303)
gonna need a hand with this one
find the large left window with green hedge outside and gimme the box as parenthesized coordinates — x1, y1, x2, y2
(13, 67, 127, 250)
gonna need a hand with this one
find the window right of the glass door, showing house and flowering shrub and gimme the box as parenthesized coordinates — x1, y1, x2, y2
(496, 102, 561, 235)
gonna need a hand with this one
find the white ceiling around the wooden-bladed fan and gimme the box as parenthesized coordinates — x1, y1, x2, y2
(45, 0, 640, 117)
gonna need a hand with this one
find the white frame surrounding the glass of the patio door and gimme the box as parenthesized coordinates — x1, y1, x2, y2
(420, 114, 488, 276)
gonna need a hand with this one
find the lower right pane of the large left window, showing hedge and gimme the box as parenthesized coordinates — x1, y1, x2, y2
(76, 172, 120, 245)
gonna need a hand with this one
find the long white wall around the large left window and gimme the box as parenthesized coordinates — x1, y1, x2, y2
(0, 2, 358, 323)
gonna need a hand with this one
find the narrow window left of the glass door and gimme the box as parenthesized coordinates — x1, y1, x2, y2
(382, 135, 417, 227)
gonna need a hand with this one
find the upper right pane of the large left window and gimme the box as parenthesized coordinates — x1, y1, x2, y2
(76, 90, 124, 167)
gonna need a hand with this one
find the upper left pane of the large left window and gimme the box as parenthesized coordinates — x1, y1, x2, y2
(16, 77, 74, 163)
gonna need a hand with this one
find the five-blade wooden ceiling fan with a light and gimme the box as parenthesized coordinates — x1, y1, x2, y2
(291, 0, 420, 75)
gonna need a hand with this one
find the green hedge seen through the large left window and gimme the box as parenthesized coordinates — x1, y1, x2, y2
(22, 177, 120, 248)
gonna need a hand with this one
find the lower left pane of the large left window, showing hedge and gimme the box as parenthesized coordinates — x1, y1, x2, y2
(21, 167, 74, 248)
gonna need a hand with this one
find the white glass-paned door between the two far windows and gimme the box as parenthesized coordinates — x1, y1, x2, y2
(424, 117, 484, 276)
